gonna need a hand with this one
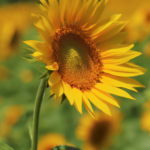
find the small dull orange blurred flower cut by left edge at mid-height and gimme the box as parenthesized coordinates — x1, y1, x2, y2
(0, 65, 9, 81)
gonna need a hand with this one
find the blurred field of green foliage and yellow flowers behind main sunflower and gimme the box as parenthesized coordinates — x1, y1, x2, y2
(0, 0, 150, 150)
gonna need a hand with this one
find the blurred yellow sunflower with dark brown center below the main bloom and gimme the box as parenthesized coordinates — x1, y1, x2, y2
(76, 108, 123, 150)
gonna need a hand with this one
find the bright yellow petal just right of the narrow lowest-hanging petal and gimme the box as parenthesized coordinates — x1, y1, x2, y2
(84, 91, 111, 116)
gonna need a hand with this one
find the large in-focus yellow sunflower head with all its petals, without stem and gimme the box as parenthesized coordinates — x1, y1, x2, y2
(25, 0, 145, 117)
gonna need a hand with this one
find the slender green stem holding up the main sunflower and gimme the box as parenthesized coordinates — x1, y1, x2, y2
(32, 79, 47, 150)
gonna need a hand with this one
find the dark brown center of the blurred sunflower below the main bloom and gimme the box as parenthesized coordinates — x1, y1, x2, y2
(89, 120, 111, 147)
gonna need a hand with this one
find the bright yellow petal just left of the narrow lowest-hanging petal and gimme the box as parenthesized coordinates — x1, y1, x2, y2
(72, 88, 82, 114)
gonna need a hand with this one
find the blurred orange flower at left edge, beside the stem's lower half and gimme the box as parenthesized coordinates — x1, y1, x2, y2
(0, 105, 24, 138)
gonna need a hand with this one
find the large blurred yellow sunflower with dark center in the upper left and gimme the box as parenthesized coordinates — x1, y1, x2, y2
(0, 3, 37, 61)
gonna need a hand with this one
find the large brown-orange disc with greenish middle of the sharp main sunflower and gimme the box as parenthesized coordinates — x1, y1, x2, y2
(52, 26, 101, 90)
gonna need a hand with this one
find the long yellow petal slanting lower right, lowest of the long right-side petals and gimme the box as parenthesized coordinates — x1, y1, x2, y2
(94, 83, 135, 100)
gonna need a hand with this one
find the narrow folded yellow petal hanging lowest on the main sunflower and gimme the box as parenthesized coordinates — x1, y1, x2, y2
(82, 94, 96, 119)
